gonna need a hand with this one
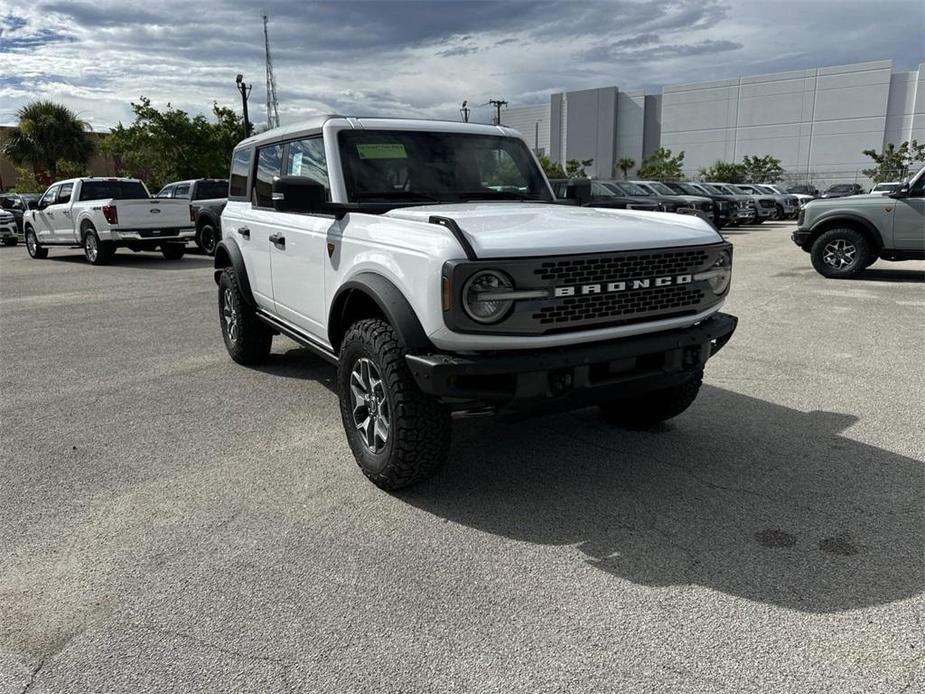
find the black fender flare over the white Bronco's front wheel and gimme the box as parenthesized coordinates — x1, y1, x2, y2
(328, 272, 434, 351)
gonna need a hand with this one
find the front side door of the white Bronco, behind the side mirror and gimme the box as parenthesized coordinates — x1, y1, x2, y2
(264, 135, 335, 343)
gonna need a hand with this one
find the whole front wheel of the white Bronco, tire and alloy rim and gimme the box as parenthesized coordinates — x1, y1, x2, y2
(337, 319, 450, 490)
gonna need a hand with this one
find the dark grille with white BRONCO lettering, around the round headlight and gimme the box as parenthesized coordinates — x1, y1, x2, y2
(444, 243, 731, 335)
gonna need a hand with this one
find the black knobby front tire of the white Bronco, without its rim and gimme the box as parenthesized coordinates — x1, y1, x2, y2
(337, 318, 451, 491)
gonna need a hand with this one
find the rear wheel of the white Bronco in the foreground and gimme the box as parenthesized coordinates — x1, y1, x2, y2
(218, 267, 273, 365)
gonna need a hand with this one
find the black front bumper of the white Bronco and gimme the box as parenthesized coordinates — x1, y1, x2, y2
(405, 313, 738, 410)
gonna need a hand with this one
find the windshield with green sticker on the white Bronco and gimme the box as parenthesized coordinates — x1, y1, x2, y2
(338, 130, 552, 202)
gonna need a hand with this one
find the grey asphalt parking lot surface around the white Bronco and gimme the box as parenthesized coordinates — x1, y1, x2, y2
(0, 223, 925, 693)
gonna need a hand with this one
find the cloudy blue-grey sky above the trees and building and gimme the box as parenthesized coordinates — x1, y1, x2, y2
(0, 0, 925, 130)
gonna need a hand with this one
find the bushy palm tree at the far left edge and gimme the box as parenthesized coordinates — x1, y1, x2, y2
(0, 101, 95, 179)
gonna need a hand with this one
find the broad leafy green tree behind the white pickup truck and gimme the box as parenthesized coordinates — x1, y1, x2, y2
(102, 96, 243, 190)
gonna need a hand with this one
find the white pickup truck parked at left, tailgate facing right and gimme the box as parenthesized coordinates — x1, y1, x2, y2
(23, 177, 196, 265)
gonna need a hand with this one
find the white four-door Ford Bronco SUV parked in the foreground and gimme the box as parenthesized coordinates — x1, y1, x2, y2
(215, 116, 736, 489)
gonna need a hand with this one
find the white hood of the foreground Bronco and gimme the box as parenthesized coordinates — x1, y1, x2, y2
(385, 202, 722, 258)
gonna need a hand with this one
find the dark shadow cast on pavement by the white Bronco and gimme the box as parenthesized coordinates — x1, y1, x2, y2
(396, 387, 925, 612)
